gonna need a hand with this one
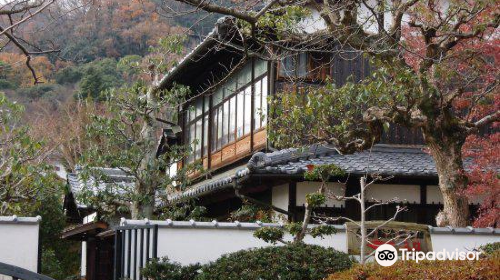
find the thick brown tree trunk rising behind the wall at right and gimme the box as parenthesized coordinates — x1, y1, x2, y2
(424, 138, 469, 227)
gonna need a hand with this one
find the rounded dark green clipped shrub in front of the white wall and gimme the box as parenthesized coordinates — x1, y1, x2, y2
(195, 243, 353, 280)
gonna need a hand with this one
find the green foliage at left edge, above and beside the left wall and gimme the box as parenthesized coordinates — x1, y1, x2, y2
(0, 94, 79, 279)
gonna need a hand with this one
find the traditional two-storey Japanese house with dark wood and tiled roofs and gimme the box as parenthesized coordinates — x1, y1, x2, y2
(157, 18, 475, 225)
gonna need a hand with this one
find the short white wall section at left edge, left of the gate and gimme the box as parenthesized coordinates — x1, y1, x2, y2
(0, 216, 41, 280)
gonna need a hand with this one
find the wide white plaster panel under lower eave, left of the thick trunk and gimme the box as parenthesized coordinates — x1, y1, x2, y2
(365, 184, 420, 203)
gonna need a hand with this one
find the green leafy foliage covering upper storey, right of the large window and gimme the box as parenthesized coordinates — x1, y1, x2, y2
(268, 65, 419, 152)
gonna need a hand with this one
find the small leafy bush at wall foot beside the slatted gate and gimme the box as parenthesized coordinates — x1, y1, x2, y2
(141, 258, 201, 280)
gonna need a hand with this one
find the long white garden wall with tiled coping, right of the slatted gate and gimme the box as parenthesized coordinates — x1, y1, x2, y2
(123, 220, 500, 265)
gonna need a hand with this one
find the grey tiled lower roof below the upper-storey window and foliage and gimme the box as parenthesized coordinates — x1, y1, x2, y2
(172, 145, 467, 200)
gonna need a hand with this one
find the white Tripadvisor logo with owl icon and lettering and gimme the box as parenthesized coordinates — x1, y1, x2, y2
(375, 244, 481, 266)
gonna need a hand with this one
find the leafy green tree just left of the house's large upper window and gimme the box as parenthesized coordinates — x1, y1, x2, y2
(80, 82, 195, 218)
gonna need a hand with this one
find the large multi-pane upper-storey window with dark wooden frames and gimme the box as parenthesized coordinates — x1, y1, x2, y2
(184, 60, 269, 167)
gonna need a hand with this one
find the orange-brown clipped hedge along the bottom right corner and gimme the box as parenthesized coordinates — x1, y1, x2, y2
(327, 258, 500, 280)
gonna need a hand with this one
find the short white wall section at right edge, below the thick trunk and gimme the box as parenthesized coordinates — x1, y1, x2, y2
(431, 233, 500, 252)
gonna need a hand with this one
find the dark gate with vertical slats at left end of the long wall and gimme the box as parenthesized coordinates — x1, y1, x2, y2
(113, 225, 158, 280)
